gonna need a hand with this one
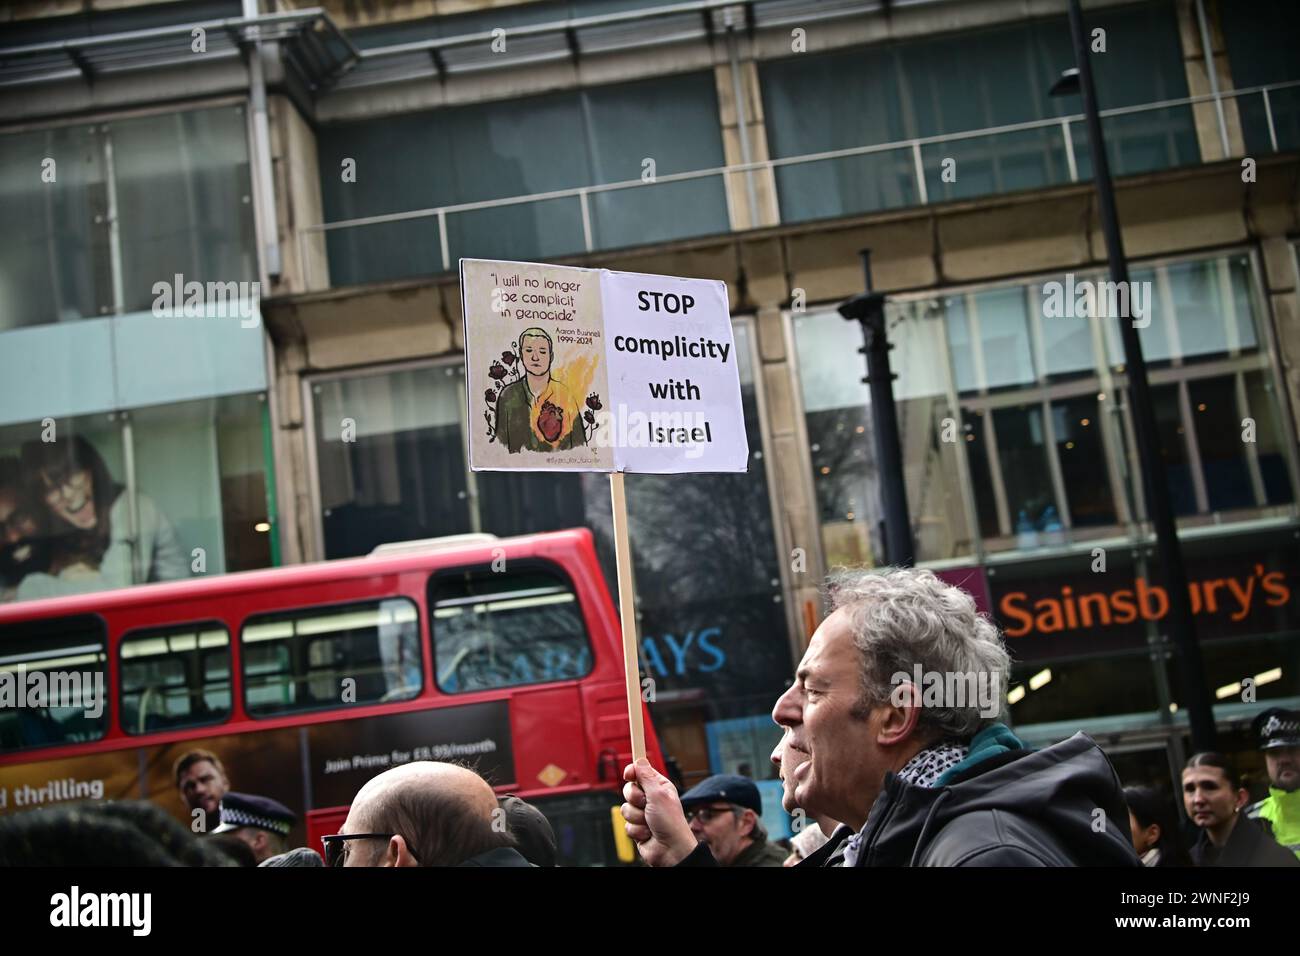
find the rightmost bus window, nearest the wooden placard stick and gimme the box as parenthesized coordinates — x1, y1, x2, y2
(429, 570, 592, 693)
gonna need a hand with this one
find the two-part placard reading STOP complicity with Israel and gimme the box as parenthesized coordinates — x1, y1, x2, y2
(460, 259, 749, 475)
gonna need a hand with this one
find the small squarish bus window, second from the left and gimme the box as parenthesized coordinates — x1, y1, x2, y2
(118, 623, 231, 734)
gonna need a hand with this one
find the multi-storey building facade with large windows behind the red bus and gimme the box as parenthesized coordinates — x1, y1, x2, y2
(0, 0, 1300, 801)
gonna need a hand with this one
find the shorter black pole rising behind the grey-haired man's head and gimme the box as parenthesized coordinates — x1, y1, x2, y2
(840, 248, 917, 566)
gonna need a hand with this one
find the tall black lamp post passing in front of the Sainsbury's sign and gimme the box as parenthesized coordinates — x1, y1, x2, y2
(1070, 0, 1216, 750)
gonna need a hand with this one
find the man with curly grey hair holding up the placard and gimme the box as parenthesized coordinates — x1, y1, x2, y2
(623, 568, 1138, 866)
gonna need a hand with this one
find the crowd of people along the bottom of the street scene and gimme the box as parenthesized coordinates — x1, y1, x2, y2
(0, 568, 1300, 866)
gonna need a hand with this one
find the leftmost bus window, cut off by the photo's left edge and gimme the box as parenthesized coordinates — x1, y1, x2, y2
(0, 615, 108, 753)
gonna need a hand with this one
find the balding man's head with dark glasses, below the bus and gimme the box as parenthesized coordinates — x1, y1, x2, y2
(342, 761, 515, 866)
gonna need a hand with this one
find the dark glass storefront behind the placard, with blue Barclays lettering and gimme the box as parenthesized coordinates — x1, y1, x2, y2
(308, 320, 793, 780)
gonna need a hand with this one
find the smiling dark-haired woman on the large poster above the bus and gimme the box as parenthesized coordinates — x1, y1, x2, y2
(18, 434, 190, 600)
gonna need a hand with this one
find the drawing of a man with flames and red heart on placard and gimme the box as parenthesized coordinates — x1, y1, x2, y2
(495, 326, 594, 454)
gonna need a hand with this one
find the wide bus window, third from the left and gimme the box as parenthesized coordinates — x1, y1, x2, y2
(241, 597, 424, 717)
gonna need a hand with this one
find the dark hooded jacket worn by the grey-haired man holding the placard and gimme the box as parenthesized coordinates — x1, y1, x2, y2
(857, 734, 1139, 866)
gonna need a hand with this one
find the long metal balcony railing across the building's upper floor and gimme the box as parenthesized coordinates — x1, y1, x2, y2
(298, 81, 1300, 289)
